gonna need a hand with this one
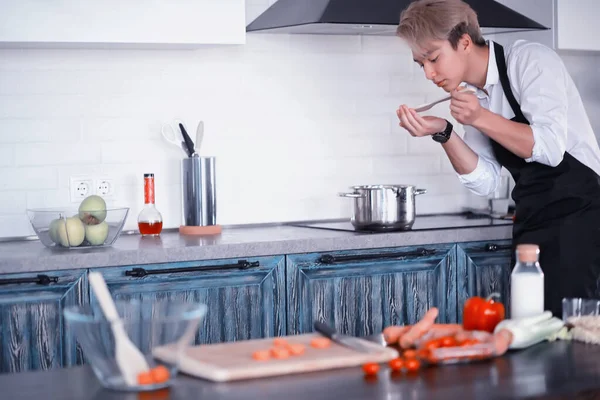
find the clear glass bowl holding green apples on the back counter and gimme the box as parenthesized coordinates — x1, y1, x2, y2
(27, 207, 129, 249)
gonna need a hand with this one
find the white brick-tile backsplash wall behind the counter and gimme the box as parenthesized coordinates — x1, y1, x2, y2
(7, 0, 588, 236)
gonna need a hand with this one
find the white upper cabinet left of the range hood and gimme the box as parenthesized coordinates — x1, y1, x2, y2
(0, 0, 246, 48)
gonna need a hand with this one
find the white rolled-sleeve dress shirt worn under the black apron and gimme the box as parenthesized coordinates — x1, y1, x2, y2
(458, 40, 600, 196)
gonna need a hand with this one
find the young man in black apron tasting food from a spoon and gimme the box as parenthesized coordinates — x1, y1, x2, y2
(397, 0, 600, 318)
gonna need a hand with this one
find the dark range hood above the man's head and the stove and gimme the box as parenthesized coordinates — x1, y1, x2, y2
(246, 0, 549, 36)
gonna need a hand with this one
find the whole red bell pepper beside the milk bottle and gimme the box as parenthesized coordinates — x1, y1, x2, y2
(463, 293, 505, 333)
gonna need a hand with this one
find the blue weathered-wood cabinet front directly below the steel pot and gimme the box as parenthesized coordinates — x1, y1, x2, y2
(287, 245, 456, 336)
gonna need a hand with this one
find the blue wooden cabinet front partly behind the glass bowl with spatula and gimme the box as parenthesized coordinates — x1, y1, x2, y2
(95, 256, 285, 344)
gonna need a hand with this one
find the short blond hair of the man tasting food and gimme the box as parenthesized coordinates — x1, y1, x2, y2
(396, 0, 485, 50)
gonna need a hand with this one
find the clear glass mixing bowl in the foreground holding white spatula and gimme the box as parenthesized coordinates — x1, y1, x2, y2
(64, 299, 207, 391)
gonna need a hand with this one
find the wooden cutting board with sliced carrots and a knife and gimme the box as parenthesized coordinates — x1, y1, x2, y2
(153, 333, 398, 382)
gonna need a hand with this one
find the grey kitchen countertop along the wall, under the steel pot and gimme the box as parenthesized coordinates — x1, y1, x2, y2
(0, 214, 512, 274)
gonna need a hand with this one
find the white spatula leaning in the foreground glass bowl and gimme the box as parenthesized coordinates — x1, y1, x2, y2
(88, 272, 150, 386)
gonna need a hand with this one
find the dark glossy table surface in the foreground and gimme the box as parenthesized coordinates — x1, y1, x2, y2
(0, 341, 600, 400)
